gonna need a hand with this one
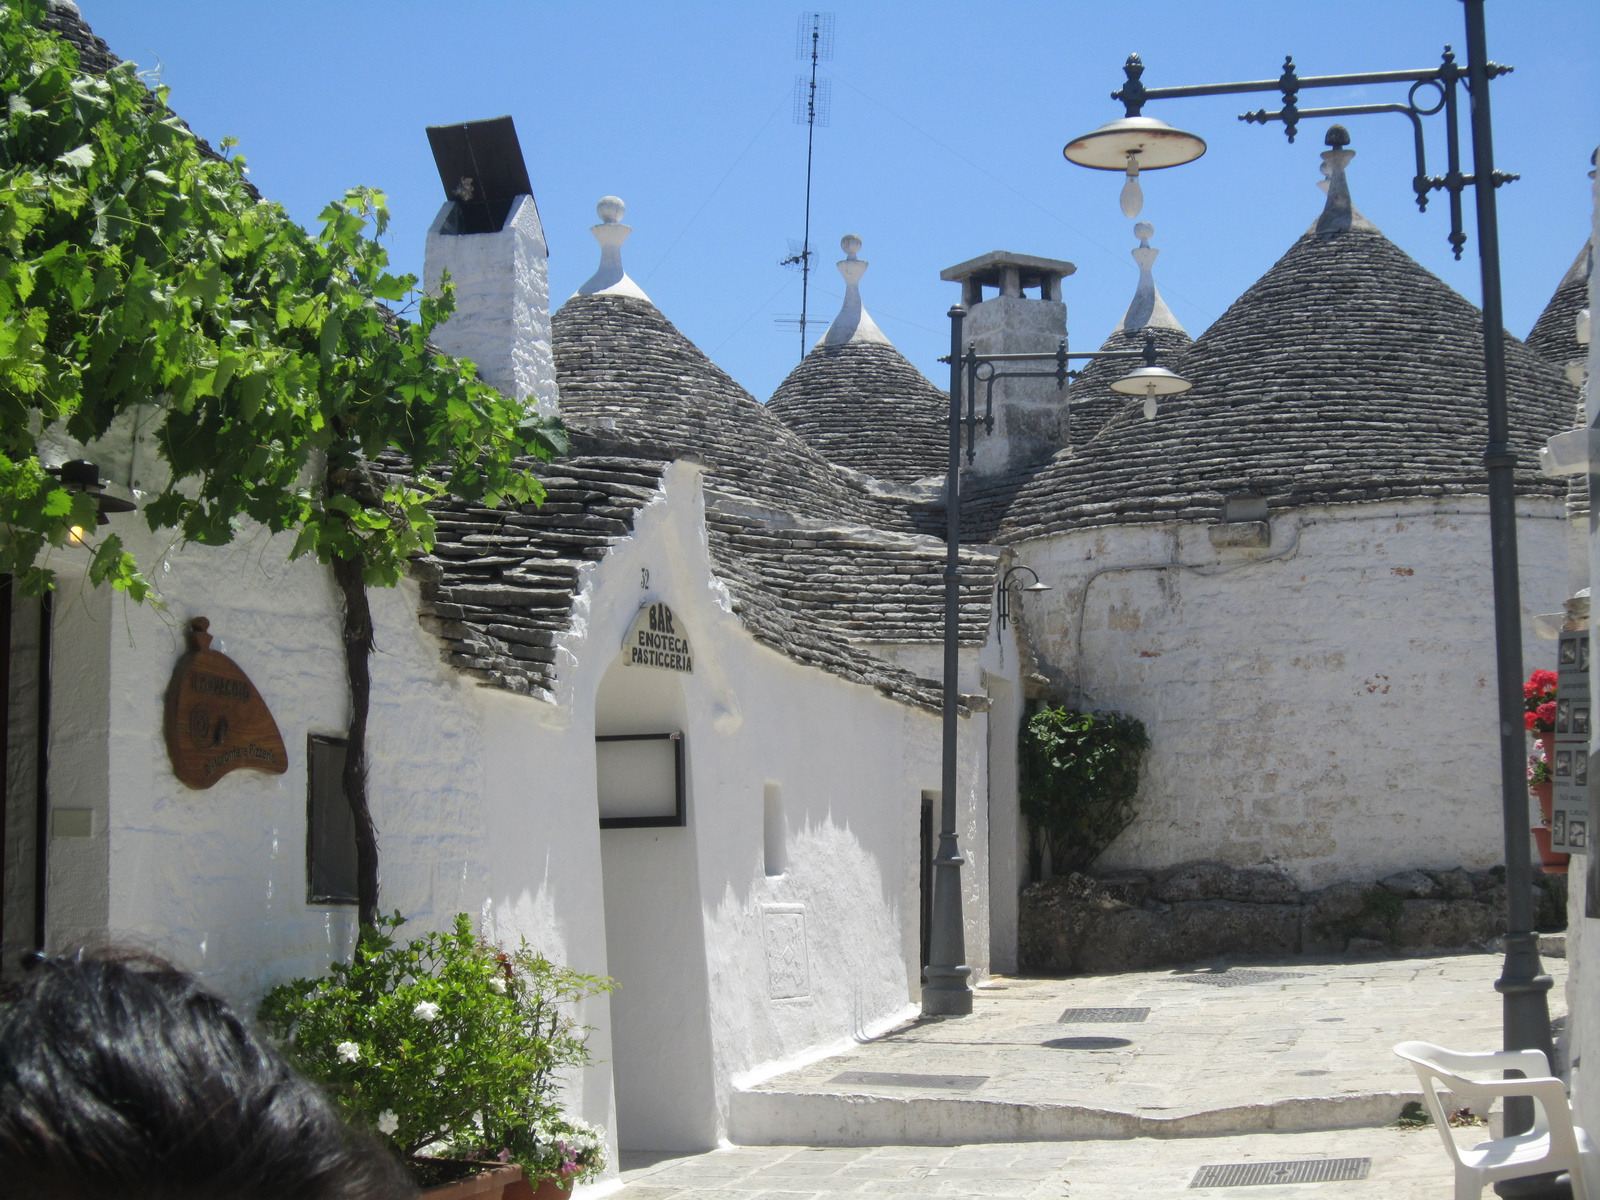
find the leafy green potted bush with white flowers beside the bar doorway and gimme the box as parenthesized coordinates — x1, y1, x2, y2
(259, 914, 611, 1200)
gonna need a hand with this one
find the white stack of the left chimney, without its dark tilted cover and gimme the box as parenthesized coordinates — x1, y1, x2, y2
(422, 195, 558, 414)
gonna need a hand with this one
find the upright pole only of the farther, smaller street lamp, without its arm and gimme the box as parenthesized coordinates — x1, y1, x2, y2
(922, 304, 973, 1016)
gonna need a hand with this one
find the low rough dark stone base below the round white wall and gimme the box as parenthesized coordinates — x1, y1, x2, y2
(1018, 862, 1566, 974)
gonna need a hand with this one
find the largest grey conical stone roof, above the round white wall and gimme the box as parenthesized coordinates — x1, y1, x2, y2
(1003, 221, 1574, 541)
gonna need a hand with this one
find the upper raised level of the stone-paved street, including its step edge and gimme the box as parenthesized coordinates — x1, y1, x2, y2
(731, 954, 1565, 1146)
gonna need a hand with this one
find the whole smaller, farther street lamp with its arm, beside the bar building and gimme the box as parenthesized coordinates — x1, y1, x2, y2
(922, 312, 1189, 1016)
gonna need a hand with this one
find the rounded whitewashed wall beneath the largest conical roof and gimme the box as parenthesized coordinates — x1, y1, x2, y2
(1016, 499, 1566, 888)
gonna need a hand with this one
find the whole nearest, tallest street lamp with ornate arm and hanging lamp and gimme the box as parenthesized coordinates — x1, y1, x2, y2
(1064, 0, 1552, 1164)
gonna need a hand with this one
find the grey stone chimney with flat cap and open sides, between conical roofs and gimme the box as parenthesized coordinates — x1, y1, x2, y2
(939, 250, 1077, 475)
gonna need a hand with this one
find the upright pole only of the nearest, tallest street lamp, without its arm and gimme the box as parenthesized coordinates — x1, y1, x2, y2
(1464, 0, 1554, 1158)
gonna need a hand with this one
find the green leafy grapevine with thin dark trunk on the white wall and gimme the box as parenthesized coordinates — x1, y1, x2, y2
(0, 0, 565, 925)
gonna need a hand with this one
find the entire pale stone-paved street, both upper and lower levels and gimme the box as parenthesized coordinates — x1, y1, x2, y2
(604, 954, 1566, 1200)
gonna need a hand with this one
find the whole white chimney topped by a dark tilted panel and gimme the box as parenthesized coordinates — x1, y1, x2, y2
(422, 117, 560, 416)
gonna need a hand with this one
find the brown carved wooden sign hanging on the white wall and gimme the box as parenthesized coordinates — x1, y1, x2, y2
(166, 616, 290, 787)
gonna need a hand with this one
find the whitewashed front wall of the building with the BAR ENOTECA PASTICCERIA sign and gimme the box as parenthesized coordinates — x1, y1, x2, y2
(37, 462, 966, 1149)
